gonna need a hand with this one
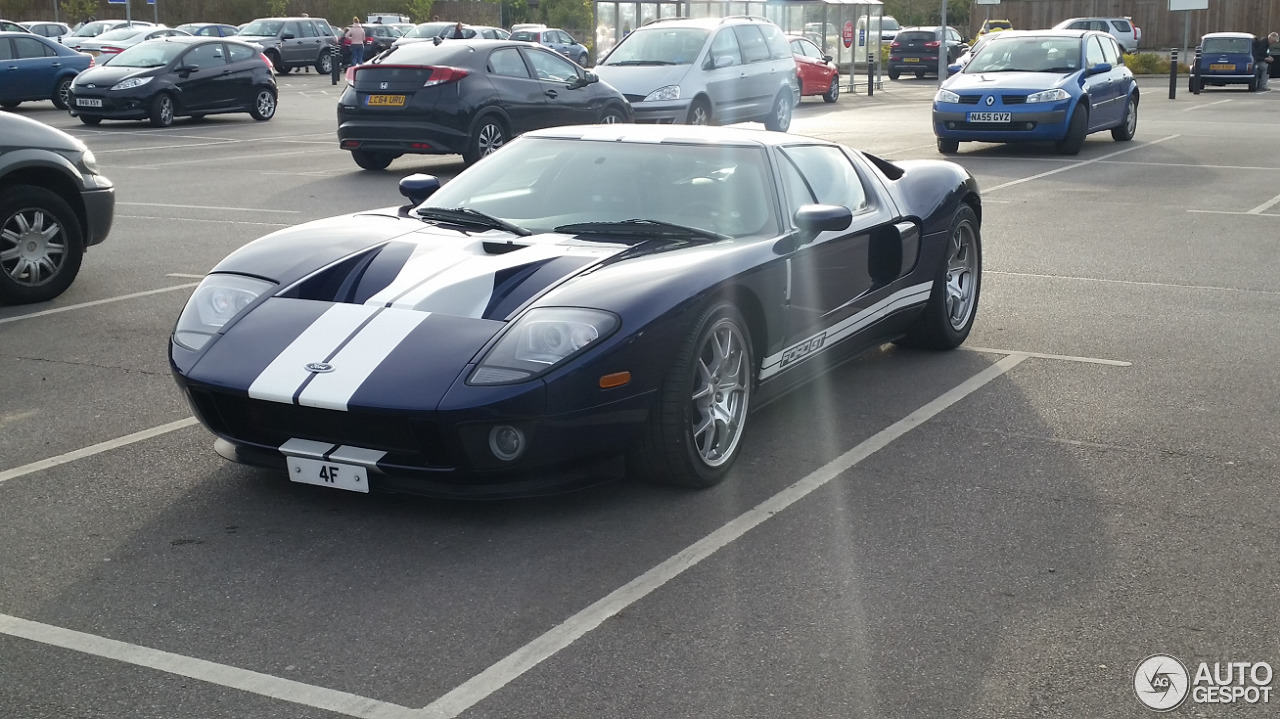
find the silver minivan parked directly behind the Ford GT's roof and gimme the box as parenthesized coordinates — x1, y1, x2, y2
(591, 17, 799, 132)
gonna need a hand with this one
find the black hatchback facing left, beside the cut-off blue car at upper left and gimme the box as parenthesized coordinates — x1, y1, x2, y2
(68, 36, 278, 127)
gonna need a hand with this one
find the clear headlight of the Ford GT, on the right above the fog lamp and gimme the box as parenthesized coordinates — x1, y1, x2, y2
(470, 307, 622, 385)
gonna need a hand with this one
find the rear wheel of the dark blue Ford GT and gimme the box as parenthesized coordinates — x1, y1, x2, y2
(897, 202, 982, 349)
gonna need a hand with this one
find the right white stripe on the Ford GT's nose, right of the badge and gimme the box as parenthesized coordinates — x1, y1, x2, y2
(298, 306, 430, 412)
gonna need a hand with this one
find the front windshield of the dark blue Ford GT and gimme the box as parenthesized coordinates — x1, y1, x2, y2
(422, 138, 778, 237)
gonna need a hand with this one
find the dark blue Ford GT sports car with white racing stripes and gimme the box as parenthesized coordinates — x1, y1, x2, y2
(170, 124, 982, 496)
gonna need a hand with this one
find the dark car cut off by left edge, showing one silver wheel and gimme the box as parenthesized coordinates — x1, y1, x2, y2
(0, 113, 115, 304)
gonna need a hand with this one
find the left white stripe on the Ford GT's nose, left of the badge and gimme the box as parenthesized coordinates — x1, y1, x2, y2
(248, 304, 380, 404)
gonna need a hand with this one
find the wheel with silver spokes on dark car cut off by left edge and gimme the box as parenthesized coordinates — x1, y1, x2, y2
(0, 184, 84, 304)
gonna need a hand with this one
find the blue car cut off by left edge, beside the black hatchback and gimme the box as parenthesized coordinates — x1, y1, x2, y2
(0, 32, 93, 110)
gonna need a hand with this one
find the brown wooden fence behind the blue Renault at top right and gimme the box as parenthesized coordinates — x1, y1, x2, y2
(969, 0, 1280, 51)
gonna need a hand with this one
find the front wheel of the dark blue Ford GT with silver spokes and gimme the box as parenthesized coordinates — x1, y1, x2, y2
(628, 302, 755, 487)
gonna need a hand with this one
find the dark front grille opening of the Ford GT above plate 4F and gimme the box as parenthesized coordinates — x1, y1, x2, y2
(191, 389, 453, 467)
